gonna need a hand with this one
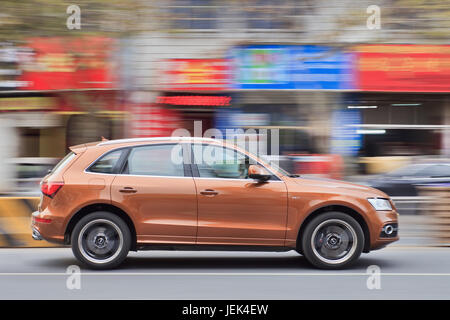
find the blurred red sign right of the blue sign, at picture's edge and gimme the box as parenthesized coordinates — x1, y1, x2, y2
(356, 45, 450, 92)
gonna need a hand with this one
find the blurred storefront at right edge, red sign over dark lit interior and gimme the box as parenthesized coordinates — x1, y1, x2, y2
(347, 45, 450, 173)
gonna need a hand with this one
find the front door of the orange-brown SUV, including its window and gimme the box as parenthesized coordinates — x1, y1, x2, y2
(192, 144, 287, 246)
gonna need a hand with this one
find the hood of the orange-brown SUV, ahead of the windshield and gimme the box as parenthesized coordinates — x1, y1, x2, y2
(291, 177, 389, 198)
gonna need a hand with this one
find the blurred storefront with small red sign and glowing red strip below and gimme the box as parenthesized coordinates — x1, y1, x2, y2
(131, 59, 234, 137)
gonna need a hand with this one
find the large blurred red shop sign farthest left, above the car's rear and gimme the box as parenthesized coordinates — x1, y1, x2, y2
(20, 37, 116, 90)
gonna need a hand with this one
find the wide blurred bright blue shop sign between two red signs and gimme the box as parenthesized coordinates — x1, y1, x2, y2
(230, 45, 355, 90)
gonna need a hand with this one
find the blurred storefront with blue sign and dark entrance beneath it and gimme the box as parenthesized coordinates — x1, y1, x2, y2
(225, 45, 354, 159)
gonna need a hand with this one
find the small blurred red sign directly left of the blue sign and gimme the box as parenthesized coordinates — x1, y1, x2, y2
(162, 59, 230, 91)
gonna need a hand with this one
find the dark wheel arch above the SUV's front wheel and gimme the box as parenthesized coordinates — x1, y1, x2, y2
(296, 204, 370, 253)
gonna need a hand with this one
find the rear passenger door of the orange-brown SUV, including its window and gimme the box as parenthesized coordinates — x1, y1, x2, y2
(111, 144, 197, 244)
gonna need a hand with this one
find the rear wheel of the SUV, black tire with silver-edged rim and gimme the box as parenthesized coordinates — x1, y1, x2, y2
(71, 211, 131, 269)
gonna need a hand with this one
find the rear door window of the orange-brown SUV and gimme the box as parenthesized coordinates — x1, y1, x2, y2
(125, 144, 184, 177)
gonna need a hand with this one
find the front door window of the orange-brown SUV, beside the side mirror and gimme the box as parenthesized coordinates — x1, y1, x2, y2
(193, 145, 251, 179)
